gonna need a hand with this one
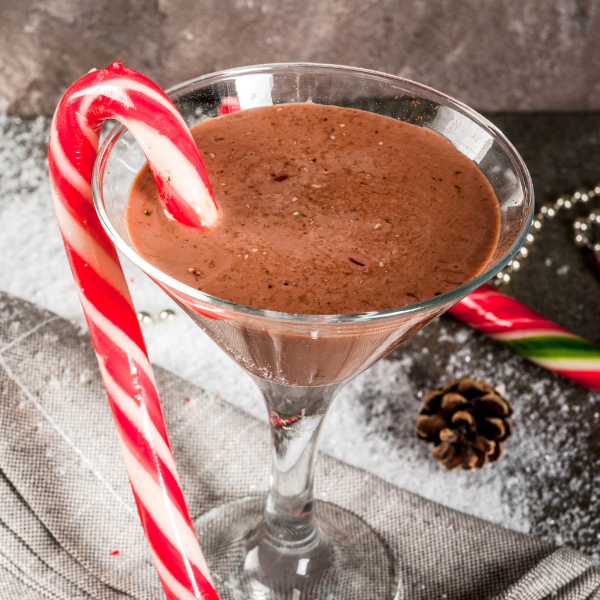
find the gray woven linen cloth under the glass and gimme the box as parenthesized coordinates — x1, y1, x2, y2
(0, 293, 600, 600)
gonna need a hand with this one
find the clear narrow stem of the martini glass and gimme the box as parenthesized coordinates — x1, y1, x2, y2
(253, 377, 341, 551)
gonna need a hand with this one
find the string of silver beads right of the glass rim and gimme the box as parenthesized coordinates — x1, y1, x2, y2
(494, 184, 600, 285)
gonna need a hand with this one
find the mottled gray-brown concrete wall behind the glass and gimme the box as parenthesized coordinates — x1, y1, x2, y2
(0, 0, 600, 116)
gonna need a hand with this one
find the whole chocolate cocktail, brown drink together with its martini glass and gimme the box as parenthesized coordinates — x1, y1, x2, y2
(94, 65, 533, 599)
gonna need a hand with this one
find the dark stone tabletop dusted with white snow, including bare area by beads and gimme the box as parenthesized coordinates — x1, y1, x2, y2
(0, 113, 600, 558)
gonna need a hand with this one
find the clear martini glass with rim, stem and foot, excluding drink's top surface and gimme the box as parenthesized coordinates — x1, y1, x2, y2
(93, 63, 533, 600)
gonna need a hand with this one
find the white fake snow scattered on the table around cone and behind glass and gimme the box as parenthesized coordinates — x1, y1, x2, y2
(0, 116, 600, 558)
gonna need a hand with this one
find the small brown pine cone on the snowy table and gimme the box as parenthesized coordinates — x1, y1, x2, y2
(417, 377, 513, 469)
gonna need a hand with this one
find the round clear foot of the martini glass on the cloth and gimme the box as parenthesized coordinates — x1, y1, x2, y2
(194, 495, 402, 600)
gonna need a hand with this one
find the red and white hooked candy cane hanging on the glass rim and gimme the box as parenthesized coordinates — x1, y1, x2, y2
(48, 62, 218, 600)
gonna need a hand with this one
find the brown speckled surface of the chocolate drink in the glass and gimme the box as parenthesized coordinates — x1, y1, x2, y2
(126, 103, 500, 314)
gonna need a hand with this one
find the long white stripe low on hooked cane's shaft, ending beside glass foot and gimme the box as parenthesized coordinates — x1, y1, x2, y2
(121, 442, 209, 577)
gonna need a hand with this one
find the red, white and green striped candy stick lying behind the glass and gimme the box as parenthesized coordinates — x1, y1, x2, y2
(448, 284, 600, 391)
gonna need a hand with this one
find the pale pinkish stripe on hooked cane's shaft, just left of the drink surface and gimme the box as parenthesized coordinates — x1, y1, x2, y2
(52, 190, 135, 302)
